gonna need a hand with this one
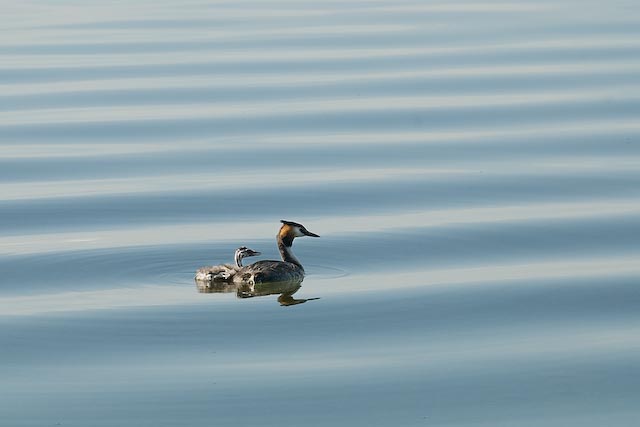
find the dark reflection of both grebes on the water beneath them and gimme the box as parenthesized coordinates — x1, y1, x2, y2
(196, 279, 320, 306)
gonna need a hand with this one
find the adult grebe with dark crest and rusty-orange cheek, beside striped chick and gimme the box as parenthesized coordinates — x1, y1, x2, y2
(233, 220, 320, 284)
